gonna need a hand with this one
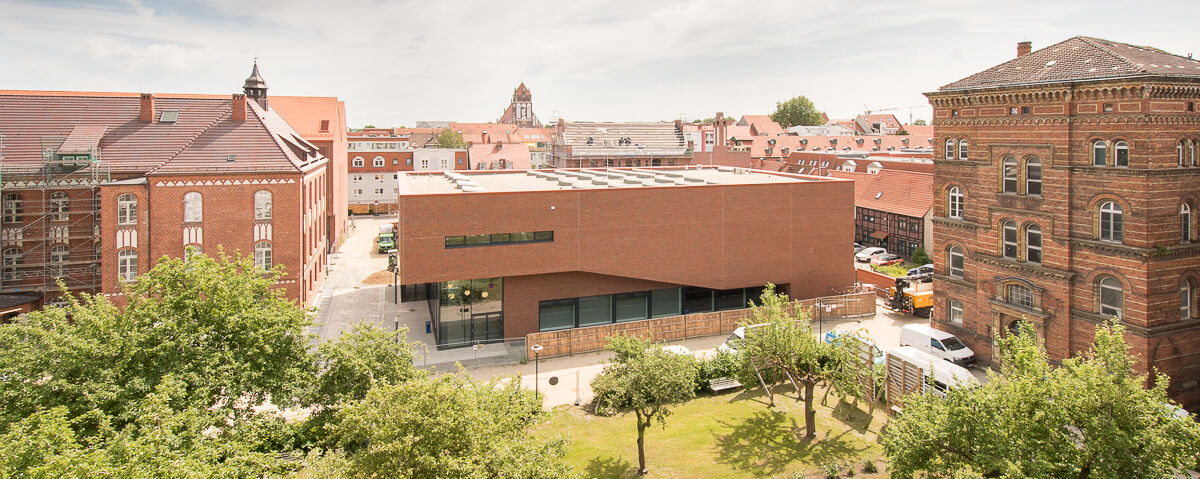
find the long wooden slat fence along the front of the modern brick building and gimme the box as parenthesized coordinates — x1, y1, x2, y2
(526, 293, 875, 358)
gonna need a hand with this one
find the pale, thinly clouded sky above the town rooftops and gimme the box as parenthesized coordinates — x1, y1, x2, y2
(0, 0, 1200, 127)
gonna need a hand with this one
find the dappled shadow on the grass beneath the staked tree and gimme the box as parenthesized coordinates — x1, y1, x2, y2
(716, 411, 866, 477)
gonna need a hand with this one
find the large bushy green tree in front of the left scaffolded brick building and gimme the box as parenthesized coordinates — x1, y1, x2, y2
(0, 253, 313, 432)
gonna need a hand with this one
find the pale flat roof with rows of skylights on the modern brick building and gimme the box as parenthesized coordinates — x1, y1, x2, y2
(398, 166, 828, 196)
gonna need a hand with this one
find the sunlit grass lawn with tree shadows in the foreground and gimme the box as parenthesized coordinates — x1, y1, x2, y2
(539, 388, 887, 479)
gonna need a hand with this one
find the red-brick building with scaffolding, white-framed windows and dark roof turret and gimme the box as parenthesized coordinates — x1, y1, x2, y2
(0, 65, 330, 304)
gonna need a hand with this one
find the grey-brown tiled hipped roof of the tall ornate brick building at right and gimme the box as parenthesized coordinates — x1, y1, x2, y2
(938, 36, 1200, 91)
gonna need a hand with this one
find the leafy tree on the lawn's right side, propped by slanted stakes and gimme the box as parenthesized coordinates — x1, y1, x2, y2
(738, 285, 854, 437)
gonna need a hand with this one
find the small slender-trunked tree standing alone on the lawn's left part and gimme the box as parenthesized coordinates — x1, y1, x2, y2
(592, 336, 700, 474)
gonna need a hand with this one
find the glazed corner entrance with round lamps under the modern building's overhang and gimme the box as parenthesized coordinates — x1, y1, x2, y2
(430, 277, 504, 348)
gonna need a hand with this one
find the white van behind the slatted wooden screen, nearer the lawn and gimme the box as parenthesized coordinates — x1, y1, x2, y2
(887, 346, 979, 406)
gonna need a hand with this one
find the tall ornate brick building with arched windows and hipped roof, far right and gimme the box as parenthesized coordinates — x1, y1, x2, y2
(926, 37, 1200, 406)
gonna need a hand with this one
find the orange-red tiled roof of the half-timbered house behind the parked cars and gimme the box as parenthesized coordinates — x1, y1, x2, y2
(829, 169, 934, 217)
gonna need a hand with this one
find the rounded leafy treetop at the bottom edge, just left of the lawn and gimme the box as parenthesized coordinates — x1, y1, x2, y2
(326, 372, 575, 479)
